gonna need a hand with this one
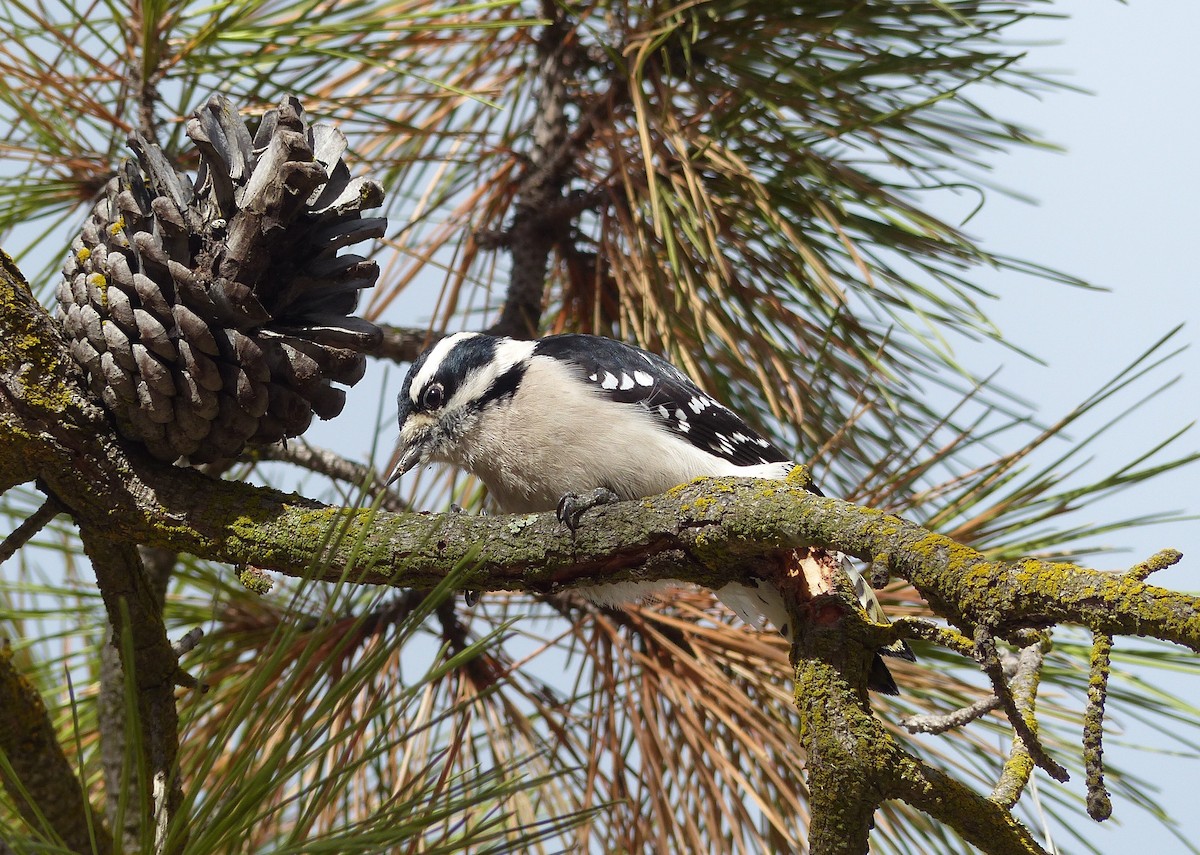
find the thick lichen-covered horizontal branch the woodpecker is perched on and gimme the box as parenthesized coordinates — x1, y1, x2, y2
(9, 386, 1200, 651)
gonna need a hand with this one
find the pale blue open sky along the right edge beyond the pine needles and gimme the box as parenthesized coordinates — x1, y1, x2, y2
(945, 0, 1200, 853)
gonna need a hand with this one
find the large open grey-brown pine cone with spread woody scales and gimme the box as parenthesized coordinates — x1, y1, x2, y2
(59, 96, 386, 464)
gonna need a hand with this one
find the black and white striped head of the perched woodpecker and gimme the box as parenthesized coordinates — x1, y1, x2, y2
(389, 333, 534, 482)
